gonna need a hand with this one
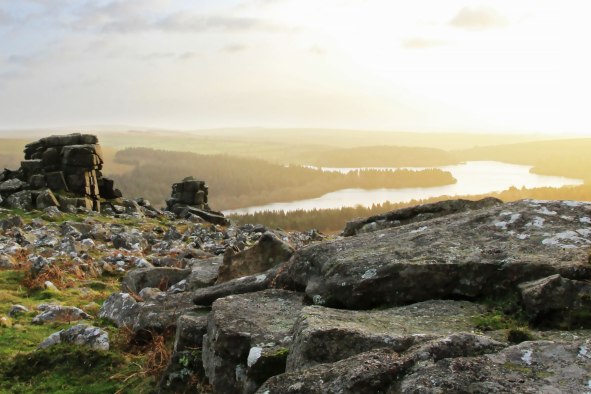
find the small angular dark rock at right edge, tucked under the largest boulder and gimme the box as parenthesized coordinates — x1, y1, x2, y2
(519, 275, 591, 313)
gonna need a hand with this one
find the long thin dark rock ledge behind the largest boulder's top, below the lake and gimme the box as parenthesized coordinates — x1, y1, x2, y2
(341, 197, 503, 237)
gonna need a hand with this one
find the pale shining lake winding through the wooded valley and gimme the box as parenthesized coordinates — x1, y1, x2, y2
(224, 161, 583, 214)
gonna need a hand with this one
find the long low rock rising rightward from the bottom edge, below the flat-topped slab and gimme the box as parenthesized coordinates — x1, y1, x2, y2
(257, 333, 505, 394)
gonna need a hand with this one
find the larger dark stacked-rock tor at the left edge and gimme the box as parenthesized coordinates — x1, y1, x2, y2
(0, 134, 121, 211)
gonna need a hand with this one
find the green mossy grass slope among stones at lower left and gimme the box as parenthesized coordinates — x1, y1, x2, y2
(0, 210, 188, 394)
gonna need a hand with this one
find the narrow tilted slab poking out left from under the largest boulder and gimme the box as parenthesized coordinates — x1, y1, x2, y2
(193, 264, 293, 305)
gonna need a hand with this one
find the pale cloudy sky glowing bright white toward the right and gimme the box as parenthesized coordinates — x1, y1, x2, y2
(0, 0, 591, 134)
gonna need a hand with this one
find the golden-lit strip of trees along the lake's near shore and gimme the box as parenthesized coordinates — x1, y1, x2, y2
(228, 185, 591, 233)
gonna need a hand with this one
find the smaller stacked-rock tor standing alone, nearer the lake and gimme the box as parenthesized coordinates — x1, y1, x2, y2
(166, 176, 228, 225)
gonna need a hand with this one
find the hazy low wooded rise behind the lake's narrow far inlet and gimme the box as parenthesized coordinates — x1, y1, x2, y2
(314, 146, 459, 168)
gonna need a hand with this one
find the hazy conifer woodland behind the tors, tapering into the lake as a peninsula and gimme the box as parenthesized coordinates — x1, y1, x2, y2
(111, 148, 456, 210)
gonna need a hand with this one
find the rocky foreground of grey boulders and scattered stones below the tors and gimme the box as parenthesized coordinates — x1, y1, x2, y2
(0, 199, 591, 394)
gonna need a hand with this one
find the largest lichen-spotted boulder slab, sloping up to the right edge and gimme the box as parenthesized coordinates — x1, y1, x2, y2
(288, 200, 591, 310)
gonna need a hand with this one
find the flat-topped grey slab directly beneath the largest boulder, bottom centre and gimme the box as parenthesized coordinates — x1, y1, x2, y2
(286, 300, 486, 372)
